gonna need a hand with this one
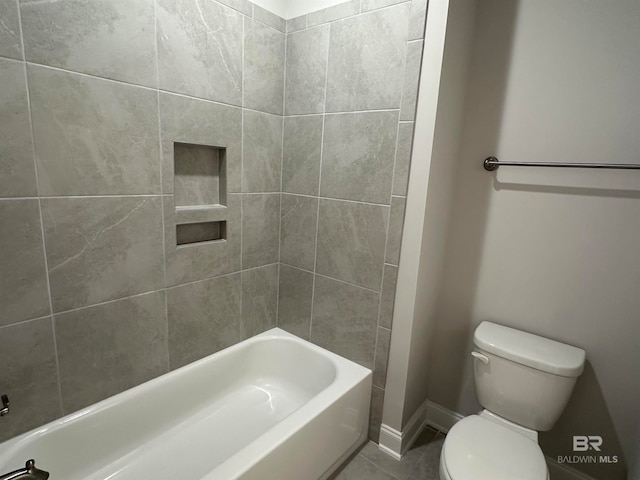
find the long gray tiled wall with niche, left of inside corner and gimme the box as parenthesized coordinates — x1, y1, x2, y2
(0, 0, 286, 441)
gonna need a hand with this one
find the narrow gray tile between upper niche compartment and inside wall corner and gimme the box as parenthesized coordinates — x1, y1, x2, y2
(242, 110, 282, 192)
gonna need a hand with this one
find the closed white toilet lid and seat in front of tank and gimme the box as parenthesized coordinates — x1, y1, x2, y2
(440, 415, 549, 480)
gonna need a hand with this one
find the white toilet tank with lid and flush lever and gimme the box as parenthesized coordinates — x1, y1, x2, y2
(472, 322, 586, 431)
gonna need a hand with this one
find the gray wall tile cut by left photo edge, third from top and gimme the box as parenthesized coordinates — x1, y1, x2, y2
(0, 200, 50, 326)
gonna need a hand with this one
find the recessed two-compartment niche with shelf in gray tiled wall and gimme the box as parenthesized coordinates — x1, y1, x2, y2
(173, 143, 227, 247)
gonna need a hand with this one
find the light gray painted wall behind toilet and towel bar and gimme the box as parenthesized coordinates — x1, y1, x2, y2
(429, 0, 640, 480)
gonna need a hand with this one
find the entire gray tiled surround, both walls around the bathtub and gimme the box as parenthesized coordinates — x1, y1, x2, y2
(0, 0, 426, 441)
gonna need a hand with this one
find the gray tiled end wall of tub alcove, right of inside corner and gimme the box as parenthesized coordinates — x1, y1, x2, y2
(278, 0, 427, 441)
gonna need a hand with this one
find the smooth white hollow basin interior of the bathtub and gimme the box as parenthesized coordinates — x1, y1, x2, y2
(0, 332, 356, 480)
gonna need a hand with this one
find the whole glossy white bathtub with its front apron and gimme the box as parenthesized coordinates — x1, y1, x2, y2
(0, 328, 371, 480)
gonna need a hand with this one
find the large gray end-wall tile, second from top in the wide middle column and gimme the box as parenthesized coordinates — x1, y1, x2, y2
(320, 111, 398, 205)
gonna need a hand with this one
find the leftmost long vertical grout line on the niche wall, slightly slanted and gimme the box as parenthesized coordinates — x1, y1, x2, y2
(16, 0, 64, 415)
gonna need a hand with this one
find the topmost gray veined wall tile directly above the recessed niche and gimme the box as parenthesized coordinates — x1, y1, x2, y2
(157, 0, 243, 105)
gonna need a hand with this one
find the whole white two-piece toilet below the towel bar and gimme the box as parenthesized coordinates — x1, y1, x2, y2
(440, 322, 586, 480)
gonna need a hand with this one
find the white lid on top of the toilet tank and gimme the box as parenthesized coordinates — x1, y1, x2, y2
(473, 322, 586, 377)
